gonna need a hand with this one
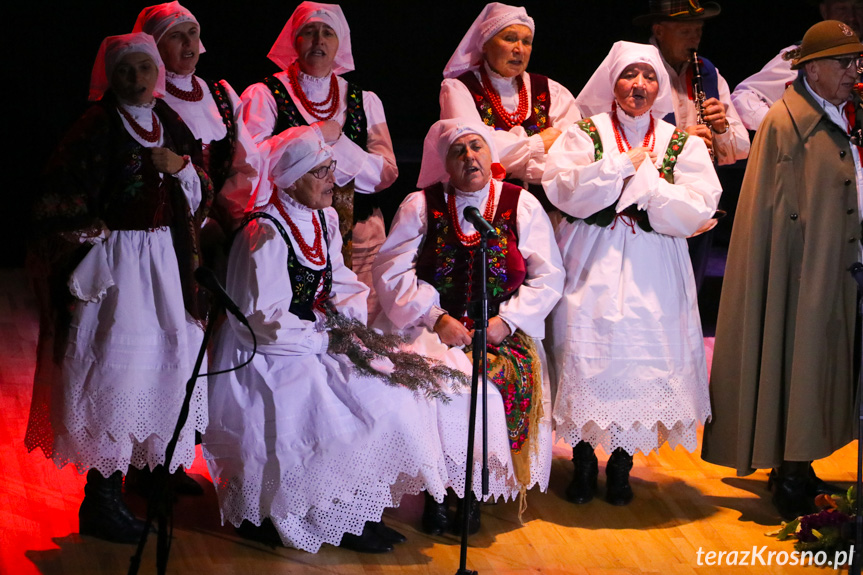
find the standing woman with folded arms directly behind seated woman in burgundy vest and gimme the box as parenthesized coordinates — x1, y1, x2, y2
(440, 2, 581, 207)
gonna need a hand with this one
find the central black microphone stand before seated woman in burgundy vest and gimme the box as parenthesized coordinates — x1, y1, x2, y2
(456, 229, 494, 575)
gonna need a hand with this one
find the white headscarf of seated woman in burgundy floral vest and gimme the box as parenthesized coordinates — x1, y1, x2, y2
(417, 118, 506, 189)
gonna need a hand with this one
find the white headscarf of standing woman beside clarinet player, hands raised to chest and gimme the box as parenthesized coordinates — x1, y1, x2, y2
(575, 41, 674, 118)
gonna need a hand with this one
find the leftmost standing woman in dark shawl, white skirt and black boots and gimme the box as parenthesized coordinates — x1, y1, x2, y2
(25, 33, 212, 543)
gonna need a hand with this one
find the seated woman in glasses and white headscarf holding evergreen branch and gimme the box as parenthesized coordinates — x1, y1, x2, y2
(198, 126, 446, 553)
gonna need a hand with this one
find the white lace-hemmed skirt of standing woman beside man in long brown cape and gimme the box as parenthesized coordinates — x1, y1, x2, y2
(551, 222, 710, 453)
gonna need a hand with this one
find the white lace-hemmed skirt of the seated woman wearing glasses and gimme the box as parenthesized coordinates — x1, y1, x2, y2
(204, 325, 447, 553)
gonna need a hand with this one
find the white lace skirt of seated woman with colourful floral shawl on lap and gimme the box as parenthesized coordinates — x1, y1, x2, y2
(406, 327, 552, 500)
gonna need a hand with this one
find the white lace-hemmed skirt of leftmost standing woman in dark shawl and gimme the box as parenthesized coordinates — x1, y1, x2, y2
(27, 229, 207, 476)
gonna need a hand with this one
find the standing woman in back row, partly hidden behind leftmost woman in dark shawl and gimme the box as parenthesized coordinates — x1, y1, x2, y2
(133, 2, 258, 232)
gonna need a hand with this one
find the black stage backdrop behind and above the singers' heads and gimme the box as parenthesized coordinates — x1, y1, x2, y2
(5, 0, 819, 266)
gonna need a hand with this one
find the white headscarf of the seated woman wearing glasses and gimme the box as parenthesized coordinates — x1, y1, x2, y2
(255, 126, 333, 207)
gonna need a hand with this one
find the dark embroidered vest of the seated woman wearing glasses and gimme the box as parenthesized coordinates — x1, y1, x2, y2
(237, 210, 333, 321)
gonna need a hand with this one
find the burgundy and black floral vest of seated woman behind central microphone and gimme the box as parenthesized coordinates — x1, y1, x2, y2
(417, 183, 527, 319)
